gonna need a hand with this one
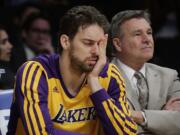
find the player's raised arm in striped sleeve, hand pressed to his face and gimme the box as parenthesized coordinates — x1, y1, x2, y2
(88, 35, 137, 135)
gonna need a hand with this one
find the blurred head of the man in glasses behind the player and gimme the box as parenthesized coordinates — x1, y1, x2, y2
(21, 13, 54, 55)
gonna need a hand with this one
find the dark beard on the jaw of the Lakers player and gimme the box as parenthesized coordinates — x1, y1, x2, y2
(69, 48, 94, 73)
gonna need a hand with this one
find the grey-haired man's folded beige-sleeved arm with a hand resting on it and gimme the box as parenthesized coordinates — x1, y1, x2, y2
(145, 72, 180, 135)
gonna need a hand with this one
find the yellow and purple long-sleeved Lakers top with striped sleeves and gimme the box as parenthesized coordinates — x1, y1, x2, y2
(8, 55, 137, 135)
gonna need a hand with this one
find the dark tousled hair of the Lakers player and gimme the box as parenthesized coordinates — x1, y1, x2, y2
(59, 5, 109, 51)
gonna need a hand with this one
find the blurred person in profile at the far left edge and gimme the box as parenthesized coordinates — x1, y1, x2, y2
(0, 25, 14, 90)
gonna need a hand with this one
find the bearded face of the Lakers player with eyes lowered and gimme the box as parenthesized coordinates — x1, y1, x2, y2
(65, 24, 104, 73)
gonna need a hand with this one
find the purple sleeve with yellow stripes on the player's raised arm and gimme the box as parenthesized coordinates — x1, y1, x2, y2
(88, 65, 137, 135)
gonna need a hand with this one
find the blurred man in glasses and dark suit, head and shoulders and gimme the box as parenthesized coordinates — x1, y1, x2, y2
(12, 13, 54, 72)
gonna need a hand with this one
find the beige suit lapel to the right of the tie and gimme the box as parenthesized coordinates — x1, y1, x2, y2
(146, 64, 160, 109)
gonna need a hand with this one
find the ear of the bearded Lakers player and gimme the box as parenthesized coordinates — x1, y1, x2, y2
(59, 34, 70, 50)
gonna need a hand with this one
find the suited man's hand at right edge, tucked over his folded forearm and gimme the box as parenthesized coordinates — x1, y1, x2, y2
(163, 97, 180, 112)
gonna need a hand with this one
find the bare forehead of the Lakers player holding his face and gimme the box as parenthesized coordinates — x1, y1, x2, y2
(75, 24, 104, 41)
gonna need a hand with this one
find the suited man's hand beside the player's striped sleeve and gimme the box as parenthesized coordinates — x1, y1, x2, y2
(131, 111, 145, 124)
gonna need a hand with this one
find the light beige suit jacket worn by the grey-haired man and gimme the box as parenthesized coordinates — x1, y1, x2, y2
(111, 58, 180, 135)
